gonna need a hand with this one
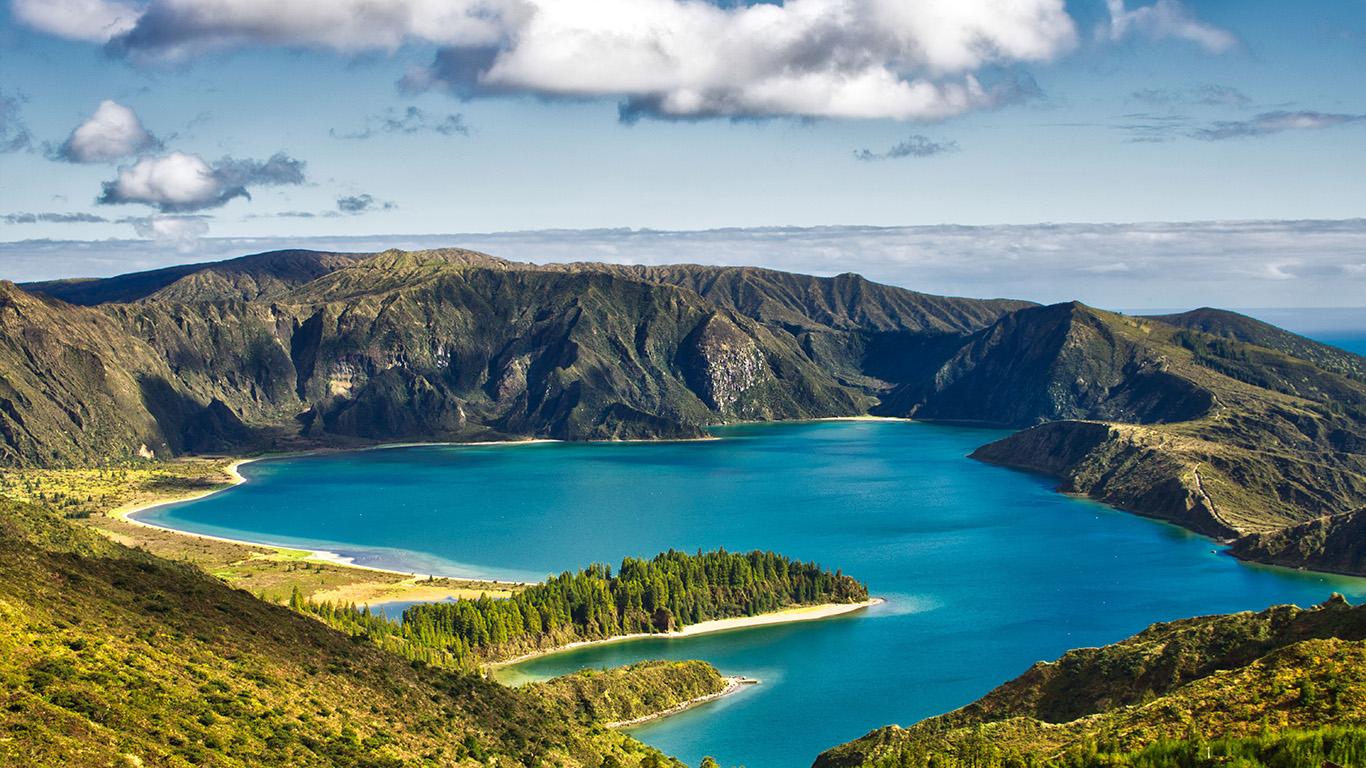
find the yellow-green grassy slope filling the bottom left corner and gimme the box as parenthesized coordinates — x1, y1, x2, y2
(0, 503, 683, 767)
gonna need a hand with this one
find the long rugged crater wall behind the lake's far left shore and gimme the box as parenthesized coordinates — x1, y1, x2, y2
(8, 250, 1032, 463)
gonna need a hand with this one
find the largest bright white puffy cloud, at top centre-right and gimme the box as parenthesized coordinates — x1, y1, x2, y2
(448, 0, 1075, 120)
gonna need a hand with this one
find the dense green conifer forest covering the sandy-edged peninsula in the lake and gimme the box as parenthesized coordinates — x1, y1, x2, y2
(290, 549, 869, 670)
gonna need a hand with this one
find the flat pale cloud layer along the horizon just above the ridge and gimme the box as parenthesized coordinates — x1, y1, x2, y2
(0, 219, 1366, 309)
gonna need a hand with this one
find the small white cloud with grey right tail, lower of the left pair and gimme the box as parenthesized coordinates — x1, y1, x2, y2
(96, 152, 305, 213)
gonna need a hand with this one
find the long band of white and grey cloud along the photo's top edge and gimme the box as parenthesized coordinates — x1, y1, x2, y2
(20, 0, 1076, 120)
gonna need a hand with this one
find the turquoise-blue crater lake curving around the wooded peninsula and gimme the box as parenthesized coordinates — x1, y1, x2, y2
(145, 421, 1366, 768)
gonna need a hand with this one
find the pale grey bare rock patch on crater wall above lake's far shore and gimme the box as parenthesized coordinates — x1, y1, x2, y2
(686, 314, 773, 411)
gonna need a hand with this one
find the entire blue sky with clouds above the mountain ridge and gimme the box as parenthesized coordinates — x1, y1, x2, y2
(0, 0, 1366, 306)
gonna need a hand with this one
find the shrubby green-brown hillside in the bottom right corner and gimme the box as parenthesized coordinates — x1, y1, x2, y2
(816, 597, 1366, 768)
